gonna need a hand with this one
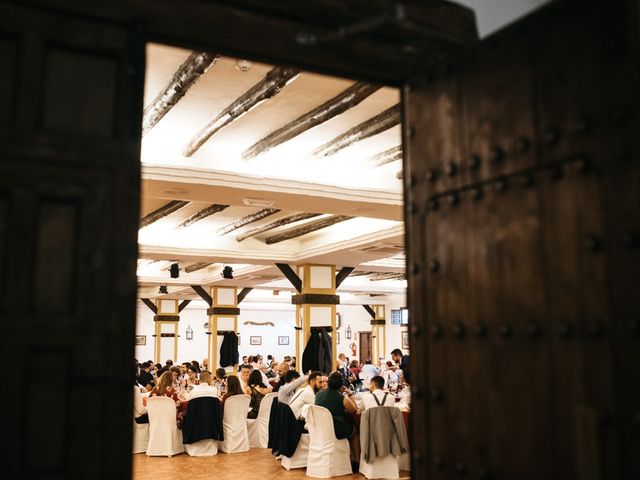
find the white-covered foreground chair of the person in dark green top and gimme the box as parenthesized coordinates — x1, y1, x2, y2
(307, 405, 353, 478)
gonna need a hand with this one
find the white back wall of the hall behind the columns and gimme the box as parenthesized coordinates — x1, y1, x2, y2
(136, 295, 408, 364)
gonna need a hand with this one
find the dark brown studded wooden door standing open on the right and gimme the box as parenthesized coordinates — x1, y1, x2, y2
(403, 2, 640, 480)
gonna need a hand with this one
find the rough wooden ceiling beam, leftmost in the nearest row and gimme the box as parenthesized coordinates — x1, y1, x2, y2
(142, 52, 218, 137)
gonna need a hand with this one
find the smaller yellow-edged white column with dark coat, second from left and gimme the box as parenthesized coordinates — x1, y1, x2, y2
(207, 287, 240, 373)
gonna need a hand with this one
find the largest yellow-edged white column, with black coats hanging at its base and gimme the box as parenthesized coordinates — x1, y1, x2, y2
(292, 264, 340, 368)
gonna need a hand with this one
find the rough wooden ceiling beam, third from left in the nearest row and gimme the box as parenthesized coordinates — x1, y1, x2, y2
(242, 82, 381, 159)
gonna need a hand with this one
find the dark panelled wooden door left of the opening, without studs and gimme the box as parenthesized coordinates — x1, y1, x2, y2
(0, 3, 144, 479)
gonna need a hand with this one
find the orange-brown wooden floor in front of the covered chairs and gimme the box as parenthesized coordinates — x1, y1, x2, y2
(133, 448, 409, 480)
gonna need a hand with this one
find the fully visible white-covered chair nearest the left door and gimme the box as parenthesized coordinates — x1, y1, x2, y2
(147, 397, 184, 457)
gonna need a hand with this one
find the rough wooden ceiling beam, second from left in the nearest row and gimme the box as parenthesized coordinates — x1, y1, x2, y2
(184, 67, 300, 157)
